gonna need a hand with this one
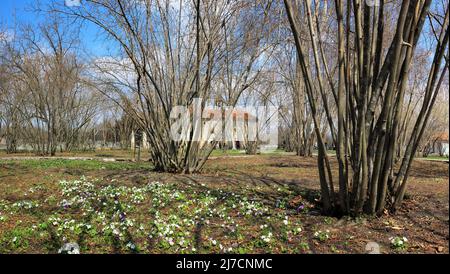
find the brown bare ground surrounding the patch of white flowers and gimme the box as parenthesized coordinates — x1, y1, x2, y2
(0, 155, 449, 253)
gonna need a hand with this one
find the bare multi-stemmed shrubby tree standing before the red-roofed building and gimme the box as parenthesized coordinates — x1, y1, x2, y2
(49, 0, 271, 173)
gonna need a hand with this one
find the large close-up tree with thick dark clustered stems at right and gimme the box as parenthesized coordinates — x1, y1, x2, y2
(284, 0, 449, 215)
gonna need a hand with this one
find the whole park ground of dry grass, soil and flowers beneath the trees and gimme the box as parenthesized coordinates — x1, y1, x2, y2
(0, 155, 449, 253)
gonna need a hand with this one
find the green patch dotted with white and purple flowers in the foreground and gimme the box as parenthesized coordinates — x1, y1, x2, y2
(0, 161, 302, 253)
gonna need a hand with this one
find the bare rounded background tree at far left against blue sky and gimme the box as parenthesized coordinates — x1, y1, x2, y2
(3, 18, 98, 155)
